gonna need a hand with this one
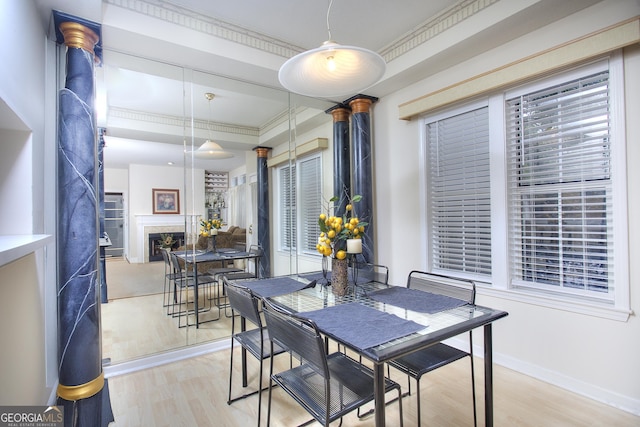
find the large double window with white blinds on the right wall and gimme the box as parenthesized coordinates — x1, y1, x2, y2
(423, 56, 629, 311)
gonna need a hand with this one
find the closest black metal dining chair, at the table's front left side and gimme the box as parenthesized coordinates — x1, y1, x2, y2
(263, 299, 403, 426)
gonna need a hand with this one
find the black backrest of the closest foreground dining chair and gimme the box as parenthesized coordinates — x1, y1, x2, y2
(263, 299, 329, 379)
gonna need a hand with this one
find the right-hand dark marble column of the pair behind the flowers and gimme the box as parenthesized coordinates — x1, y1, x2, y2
(349, 95, 378, 263)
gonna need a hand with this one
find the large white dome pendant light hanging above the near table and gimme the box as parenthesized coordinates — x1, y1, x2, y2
(278, 0, 386, 98)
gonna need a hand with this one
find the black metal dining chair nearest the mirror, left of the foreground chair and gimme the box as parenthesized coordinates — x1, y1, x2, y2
(223, 278, 285, 426)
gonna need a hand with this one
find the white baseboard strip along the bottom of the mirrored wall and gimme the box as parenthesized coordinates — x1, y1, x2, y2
(103, 338, 231, 378)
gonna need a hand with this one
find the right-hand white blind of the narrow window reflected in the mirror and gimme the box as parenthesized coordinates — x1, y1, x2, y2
(298, 156, 322, 253)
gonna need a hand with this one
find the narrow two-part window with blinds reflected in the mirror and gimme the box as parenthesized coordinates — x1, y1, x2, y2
(278, 155, 322, 253)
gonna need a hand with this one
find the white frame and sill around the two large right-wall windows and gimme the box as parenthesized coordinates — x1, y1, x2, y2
(420, 52, 631, 321)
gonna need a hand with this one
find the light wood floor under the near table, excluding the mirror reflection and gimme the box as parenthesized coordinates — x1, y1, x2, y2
(109, 350, 640, 427)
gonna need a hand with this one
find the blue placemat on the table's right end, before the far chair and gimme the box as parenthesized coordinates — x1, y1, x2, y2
(369, 286, 466, 314)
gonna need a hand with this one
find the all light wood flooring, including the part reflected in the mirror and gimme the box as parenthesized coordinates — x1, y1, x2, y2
(102, 260, 640, 427)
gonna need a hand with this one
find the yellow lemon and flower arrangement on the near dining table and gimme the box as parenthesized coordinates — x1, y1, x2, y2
(316, 195, 369, 259)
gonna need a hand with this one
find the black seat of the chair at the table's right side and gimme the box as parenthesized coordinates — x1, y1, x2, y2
(389, 343, 469, 378)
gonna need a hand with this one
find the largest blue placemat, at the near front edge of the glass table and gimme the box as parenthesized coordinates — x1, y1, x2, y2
(300, 302, 425, 350)
